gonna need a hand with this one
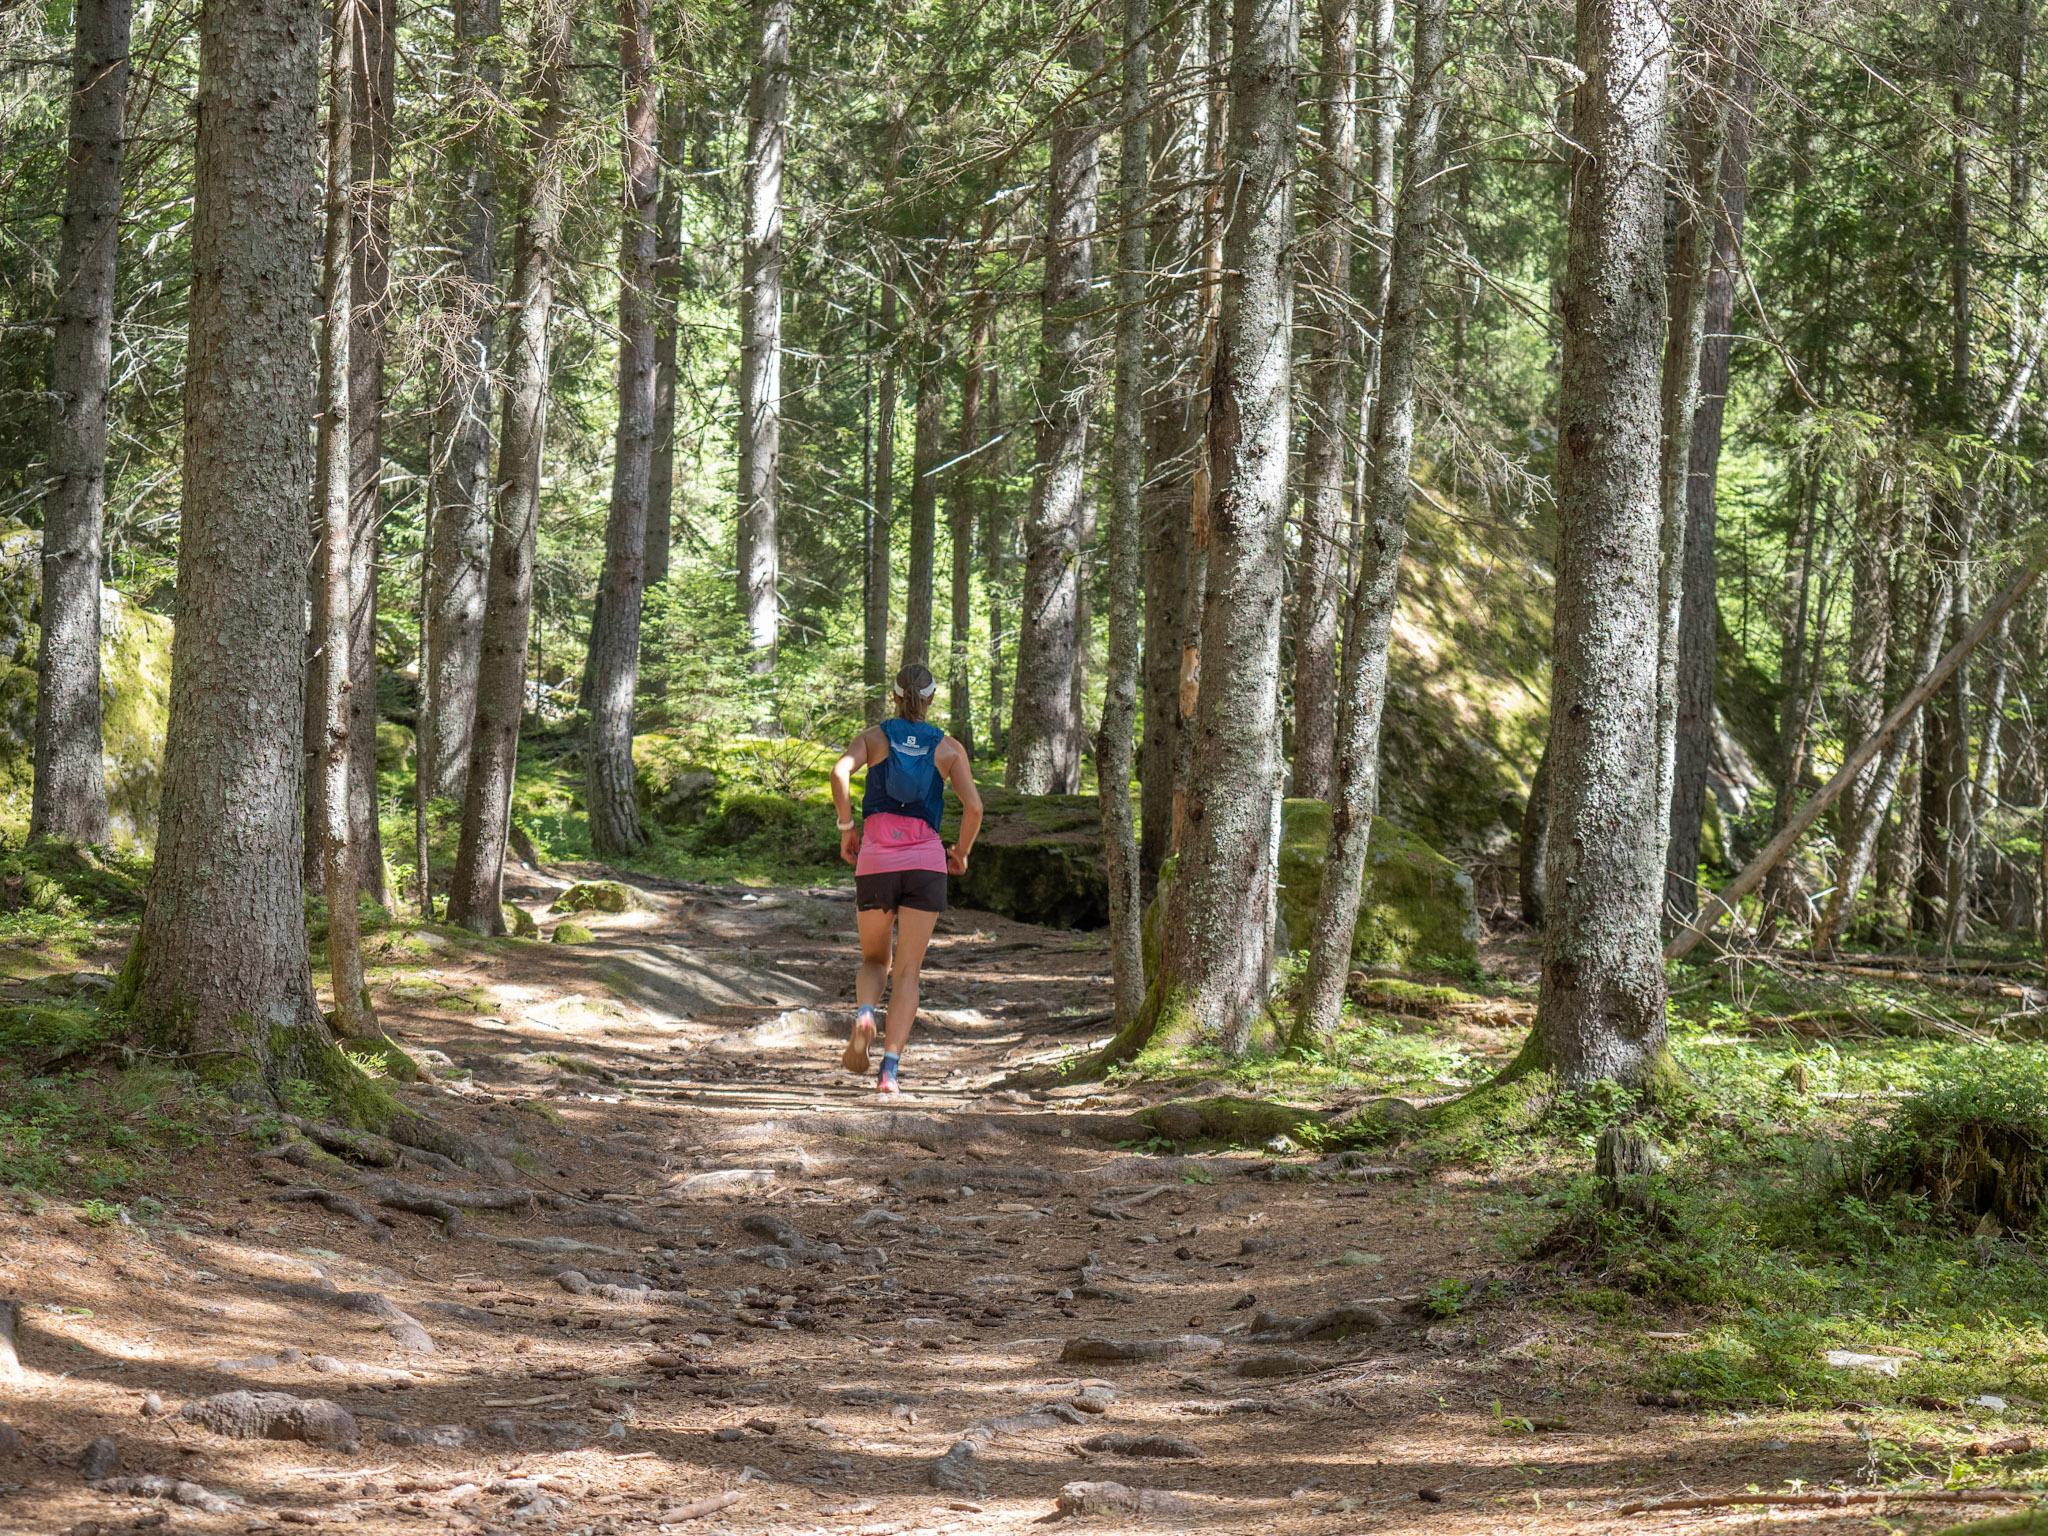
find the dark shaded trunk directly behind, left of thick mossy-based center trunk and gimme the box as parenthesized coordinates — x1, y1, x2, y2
(1139, 8, 1204, 899)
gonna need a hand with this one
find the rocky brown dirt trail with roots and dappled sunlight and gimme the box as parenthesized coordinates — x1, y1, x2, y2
(0, 889, 1896, 1536)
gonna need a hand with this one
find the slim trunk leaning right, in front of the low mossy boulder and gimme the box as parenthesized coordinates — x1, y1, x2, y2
(1294, 0, 1450, 1042)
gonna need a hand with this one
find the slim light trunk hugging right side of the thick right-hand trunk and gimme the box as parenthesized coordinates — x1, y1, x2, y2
(1657, 16, 1741, 913)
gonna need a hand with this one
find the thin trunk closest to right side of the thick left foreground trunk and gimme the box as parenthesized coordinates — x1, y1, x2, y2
(307, 0, 377, 1038)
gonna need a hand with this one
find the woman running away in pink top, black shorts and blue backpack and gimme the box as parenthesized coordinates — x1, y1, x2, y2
(831, 666, 981, 1094)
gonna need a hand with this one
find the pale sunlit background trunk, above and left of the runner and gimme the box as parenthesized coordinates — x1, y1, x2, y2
(739, 0, 791, 676)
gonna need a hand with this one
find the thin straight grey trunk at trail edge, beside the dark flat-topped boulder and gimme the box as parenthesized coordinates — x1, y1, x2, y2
(1096, 0, 1151, 1028)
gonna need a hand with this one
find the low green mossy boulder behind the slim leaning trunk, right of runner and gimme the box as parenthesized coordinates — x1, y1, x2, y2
(1280, 801, 1479, 971)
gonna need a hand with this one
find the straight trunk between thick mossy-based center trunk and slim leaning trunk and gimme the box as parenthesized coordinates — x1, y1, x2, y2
(1294, 0, 1358, 799)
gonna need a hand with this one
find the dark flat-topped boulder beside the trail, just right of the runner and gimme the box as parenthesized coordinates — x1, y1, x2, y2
(944, 788, 1110, 928)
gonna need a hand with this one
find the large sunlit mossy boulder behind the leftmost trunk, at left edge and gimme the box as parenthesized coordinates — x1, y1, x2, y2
(0, 524, 172, 852)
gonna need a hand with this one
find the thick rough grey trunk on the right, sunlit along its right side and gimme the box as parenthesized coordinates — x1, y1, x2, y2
(1530, 0, 1671, 1090)
